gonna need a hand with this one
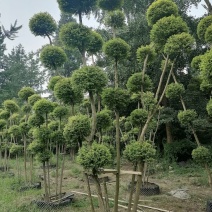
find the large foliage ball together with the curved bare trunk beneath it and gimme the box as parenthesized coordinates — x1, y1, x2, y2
(72, 66, 107, 142)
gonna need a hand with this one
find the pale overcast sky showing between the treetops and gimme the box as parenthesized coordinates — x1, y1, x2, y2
(0, 0, 208, 52)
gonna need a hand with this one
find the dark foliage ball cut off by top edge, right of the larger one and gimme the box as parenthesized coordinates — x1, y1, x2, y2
(98, 0, 124, 11)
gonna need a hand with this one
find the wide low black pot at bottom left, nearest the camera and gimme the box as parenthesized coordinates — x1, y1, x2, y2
(32, 193, 74, 209)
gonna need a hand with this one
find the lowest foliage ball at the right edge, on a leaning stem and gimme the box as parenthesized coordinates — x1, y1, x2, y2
(192, 146, 212, 164)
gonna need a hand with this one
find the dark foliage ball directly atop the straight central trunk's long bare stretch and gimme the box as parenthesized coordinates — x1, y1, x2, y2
(102, 88, 130, 112)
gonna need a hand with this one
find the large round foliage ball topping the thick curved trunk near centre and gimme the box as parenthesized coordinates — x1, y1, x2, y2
(72, 66, 107, 93)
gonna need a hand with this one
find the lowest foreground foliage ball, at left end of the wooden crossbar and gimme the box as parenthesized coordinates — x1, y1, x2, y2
(77, 142, 112, 174)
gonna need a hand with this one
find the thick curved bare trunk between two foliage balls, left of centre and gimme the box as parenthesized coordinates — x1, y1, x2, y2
(88, 92, 97, 144)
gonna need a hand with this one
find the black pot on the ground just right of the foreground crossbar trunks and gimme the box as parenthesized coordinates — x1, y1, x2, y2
(128, 182, 160, 196)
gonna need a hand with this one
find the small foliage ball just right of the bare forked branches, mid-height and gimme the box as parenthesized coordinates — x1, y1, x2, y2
(166, 83, 185, 99)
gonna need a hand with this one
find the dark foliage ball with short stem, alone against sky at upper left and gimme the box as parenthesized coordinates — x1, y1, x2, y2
(29, 12, 57, 44)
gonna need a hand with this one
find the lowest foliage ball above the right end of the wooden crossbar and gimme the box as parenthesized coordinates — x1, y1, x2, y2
(123, 141, 156, 164)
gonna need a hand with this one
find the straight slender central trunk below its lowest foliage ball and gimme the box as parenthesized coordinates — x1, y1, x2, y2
(114, 111, 121, 212)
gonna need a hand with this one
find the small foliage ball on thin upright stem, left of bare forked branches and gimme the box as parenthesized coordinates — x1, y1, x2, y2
(136, 45, 156, 63)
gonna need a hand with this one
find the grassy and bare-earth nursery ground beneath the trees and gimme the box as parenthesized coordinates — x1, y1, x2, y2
(0, 158, 212, 212)
